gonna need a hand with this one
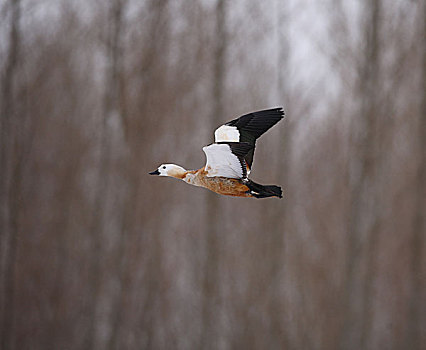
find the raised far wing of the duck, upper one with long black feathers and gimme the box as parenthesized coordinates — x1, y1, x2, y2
(214, 107, 284, 168)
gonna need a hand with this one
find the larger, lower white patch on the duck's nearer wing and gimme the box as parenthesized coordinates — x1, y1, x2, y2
(203, 143, 243, 179)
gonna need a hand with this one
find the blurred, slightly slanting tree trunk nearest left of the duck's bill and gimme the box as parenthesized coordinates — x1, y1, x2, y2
(86, 0, 124, 349)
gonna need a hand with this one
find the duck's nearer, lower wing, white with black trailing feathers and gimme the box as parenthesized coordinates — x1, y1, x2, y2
(203, 142, 253, 179)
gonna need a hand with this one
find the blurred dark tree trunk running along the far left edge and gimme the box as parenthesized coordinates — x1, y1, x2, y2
(0, 0, 22, 349)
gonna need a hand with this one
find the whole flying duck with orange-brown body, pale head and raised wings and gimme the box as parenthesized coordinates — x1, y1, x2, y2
(149, 108, 284, 198)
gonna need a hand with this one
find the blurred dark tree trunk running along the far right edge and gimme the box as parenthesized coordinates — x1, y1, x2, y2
(406, 1, 426, 350)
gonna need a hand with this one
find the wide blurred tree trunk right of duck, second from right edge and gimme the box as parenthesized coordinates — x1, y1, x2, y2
(340, 0, 381, 349)
